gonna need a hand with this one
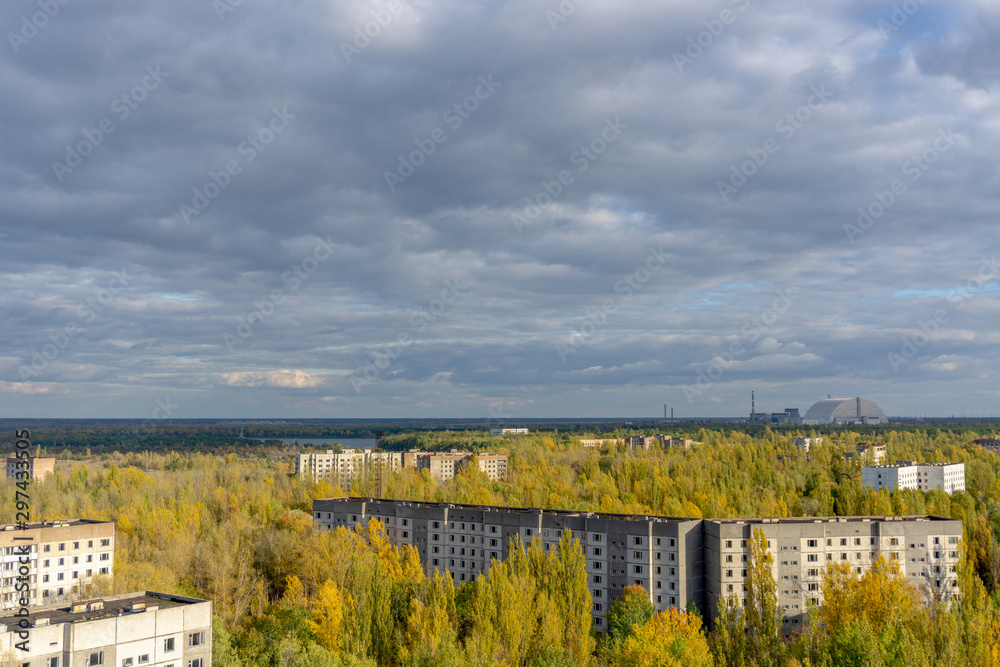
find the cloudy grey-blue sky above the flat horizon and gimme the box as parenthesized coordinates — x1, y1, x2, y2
(0, 0, 1000, 424)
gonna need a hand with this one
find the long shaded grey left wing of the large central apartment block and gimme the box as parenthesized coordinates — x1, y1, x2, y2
(313, 498, 703, 630)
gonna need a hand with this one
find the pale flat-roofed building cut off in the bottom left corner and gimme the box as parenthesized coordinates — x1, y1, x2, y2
(0, 592, 212, 667)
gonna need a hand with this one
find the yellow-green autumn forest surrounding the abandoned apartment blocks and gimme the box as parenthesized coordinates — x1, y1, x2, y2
(0, 427, 1000, 667)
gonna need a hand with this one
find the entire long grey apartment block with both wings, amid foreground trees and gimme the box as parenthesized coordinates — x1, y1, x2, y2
(313, 498, 962, 631)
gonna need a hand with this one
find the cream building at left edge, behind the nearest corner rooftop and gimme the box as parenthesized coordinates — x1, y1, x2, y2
(0, 519, 115, 609)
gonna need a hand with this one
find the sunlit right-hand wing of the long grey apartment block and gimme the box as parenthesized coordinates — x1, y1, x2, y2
(704, 516, 962, 631)
